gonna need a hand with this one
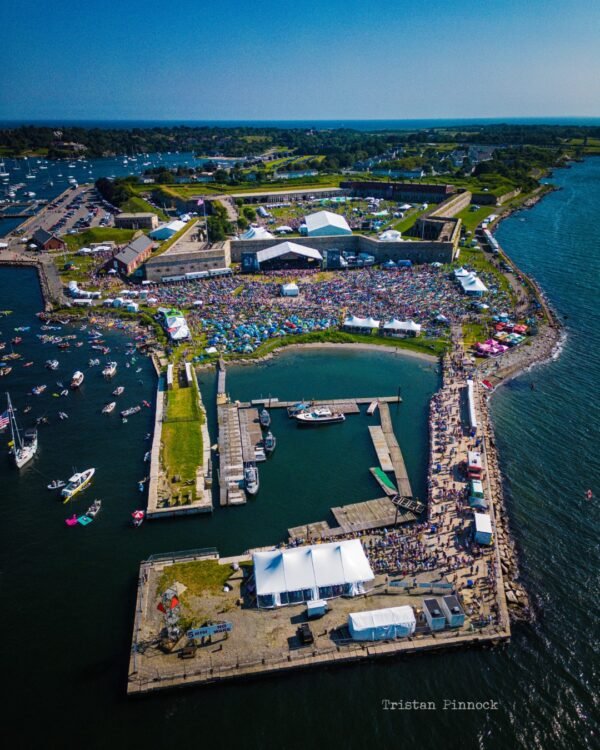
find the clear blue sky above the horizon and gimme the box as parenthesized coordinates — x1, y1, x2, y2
(0, 0, 600, 120)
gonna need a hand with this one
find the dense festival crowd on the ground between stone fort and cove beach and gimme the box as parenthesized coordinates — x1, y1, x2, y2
(136, 266, 508, 352)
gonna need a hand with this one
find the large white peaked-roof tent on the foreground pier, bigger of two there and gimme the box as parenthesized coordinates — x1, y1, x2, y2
(253, 539, 374, 607)
